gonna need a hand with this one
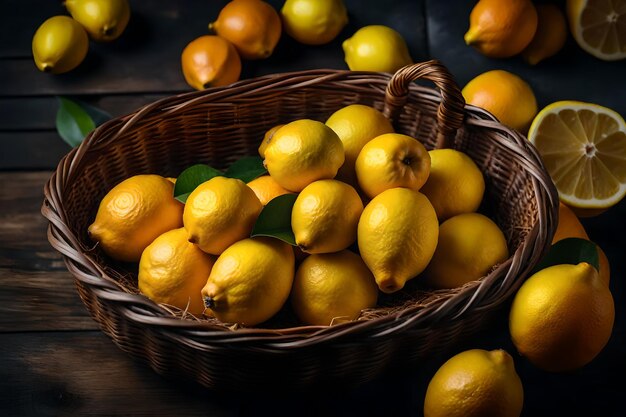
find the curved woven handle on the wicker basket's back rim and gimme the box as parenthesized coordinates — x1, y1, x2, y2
(383, 59, 465, 148)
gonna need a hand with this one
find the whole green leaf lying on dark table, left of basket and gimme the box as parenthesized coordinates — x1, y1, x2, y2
(56, 97, 111, 147)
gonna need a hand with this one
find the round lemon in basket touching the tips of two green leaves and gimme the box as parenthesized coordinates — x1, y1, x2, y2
(183, 177, 263, 255)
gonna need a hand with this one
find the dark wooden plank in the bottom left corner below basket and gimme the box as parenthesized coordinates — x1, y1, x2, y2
(0, 332, 239, 417)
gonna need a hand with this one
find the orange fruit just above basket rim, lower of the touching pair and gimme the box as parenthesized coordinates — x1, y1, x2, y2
(180, 35, 241, 90)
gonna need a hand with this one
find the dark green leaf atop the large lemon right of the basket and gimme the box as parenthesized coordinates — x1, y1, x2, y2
(533, 237, 600, 273)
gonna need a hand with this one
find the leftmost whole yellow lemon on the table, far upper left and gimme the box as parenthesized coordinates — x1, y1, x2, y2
(32, 16, 89, 74)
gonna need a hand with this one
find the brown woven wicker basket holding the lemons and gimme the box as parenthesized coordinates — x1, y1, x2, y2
(42, 61, 558, 391)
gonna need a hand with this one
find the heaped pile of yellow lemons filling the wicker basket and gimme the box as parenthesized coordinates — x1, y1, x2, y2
(89, 104, 508, 326)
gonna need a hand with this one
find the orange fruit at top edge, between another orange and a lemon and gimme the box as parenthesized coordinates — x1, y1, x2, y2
(209, 0, 282, 59)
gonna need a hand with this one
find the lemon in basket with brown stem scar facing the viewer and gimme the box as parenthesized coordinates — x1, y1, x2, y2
(355, 133, 430, 198)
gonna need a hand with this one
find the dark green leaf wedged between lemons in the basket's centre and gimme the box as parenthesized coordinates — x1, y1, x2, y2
(251, 194, 298, 246)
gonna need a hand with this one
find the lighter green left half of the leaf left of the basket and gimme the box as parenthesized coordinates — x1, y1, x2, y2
(56, 97, 96, 147)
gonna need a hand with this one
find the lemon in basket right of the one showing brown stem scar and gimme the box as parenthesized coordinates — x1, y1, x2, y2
(420, 149, 485, 221)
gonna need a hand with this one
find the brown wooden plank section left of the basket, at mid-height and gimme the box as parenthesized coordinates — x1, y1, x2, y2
(0, 172, 98, 332)
